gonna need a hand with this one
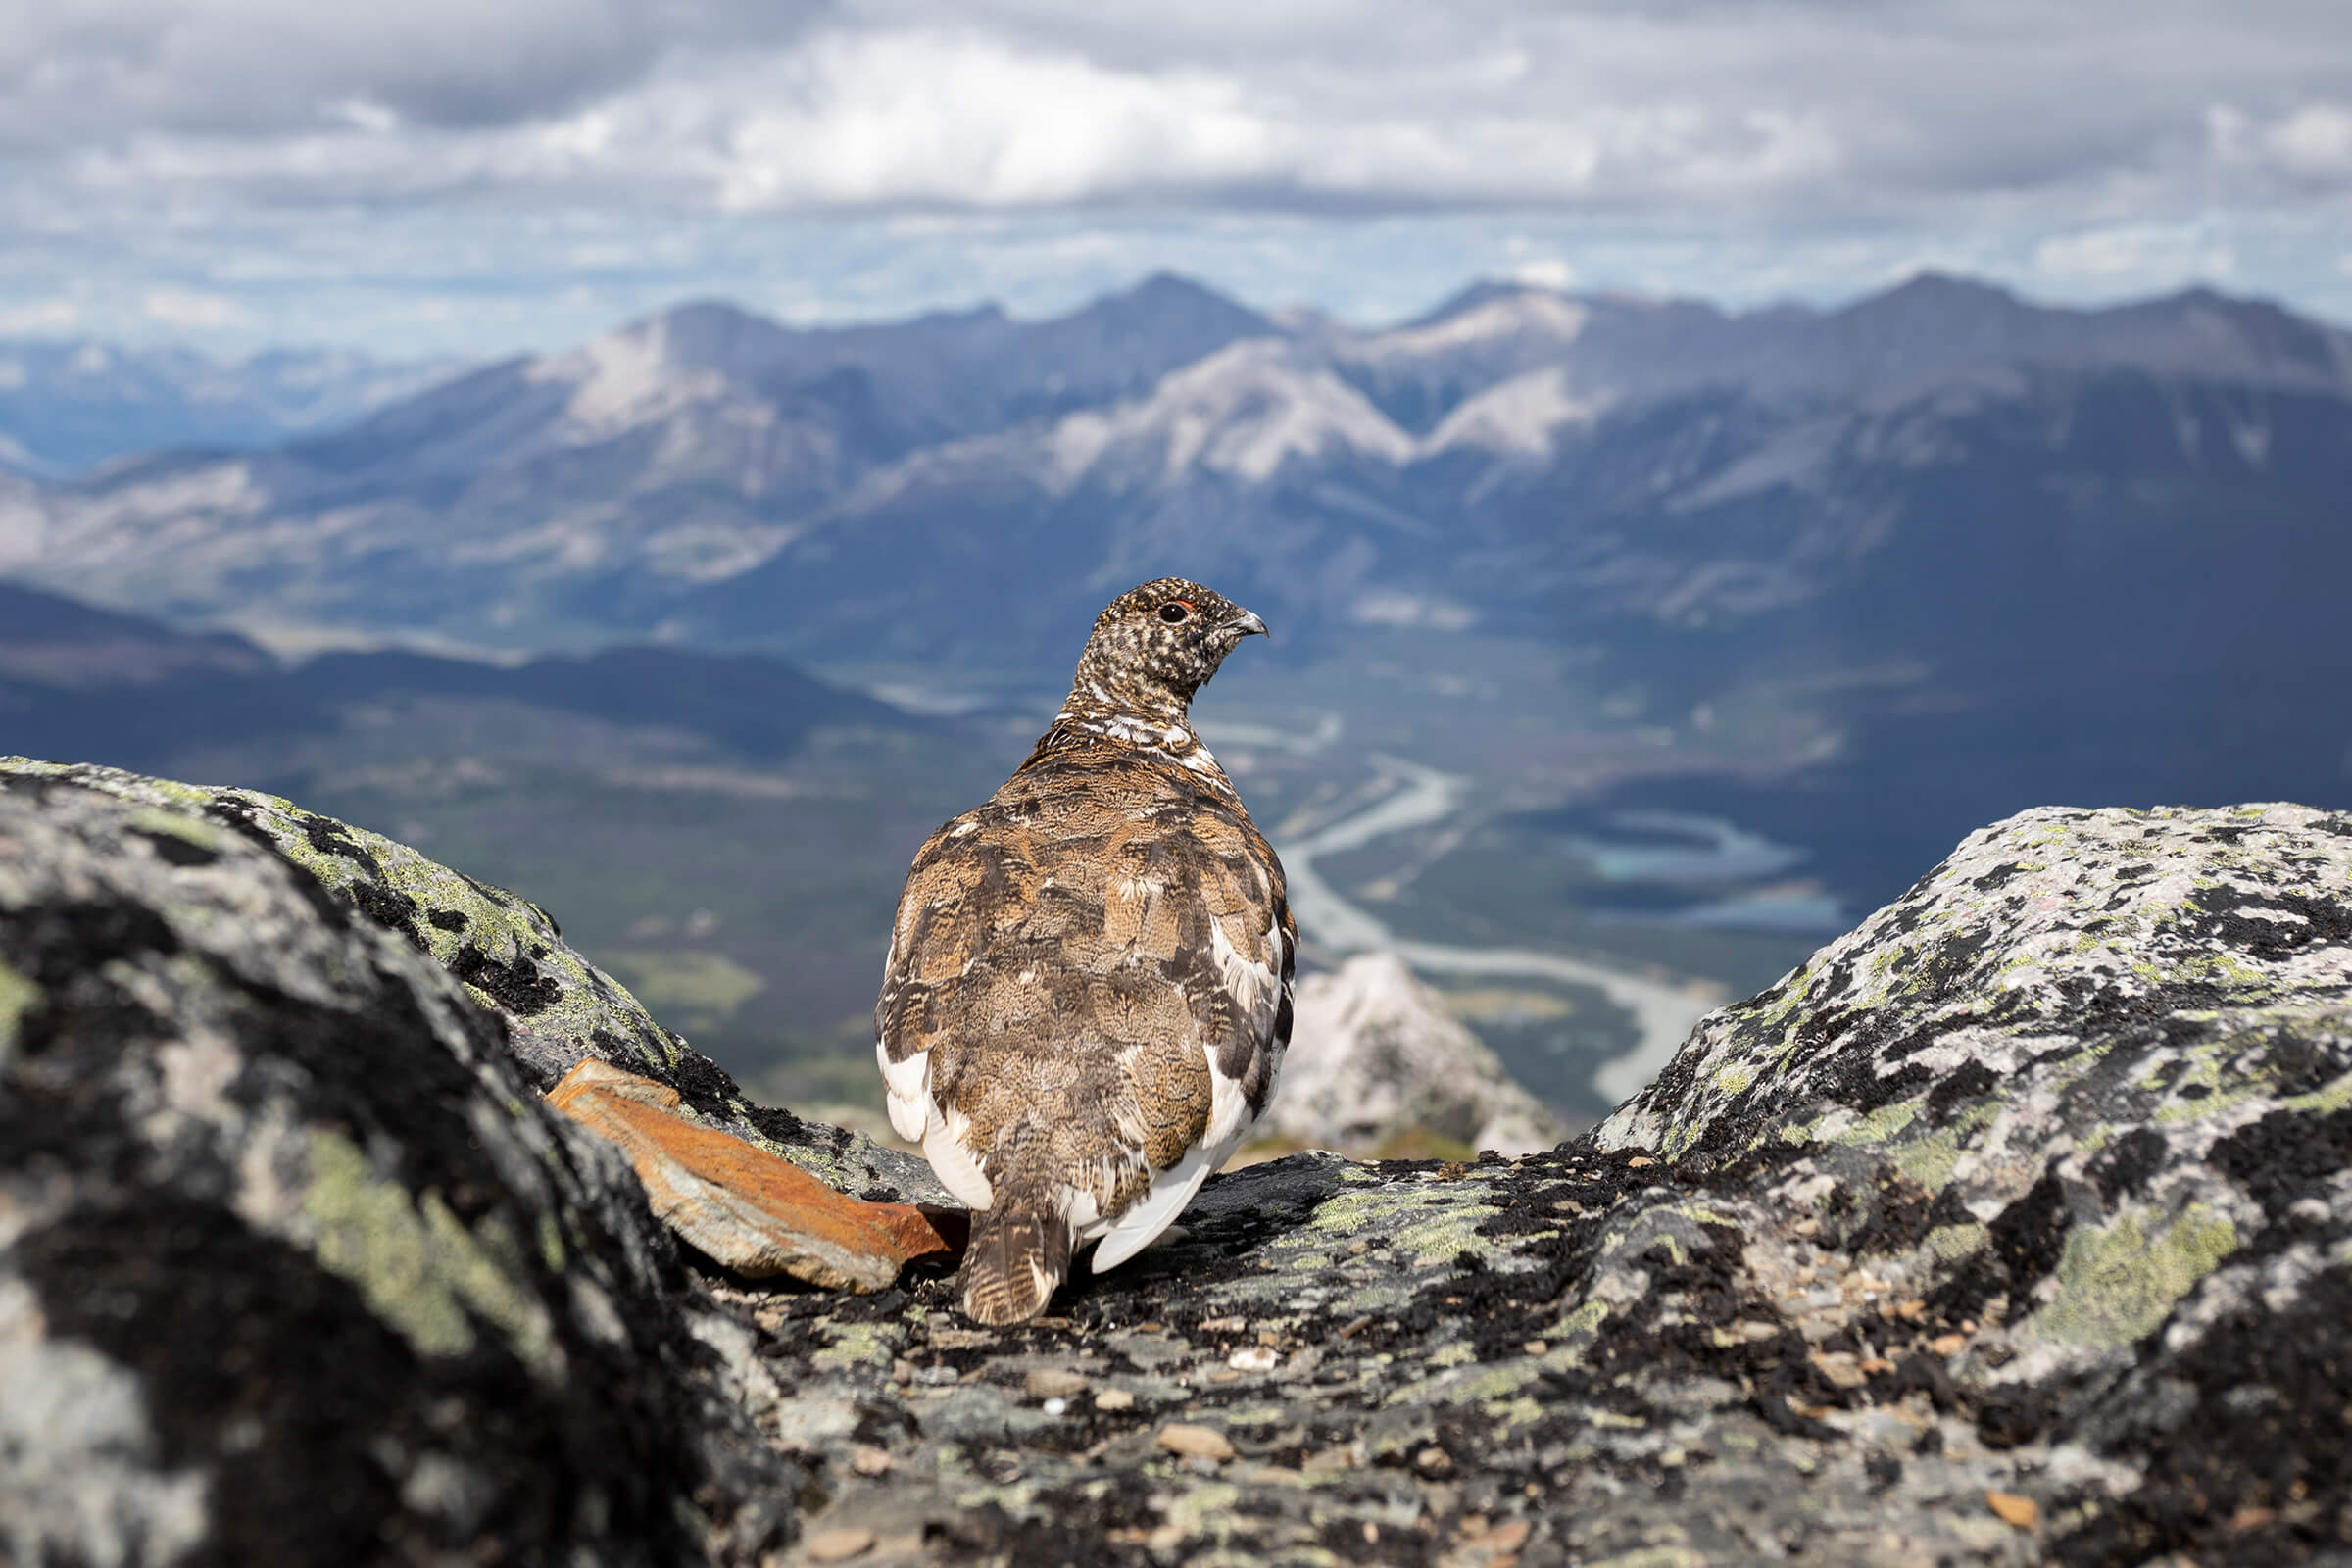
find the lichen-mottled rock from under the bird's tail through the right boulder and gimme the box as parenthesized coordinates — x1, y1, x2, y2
(736, 807, 2352, 1566)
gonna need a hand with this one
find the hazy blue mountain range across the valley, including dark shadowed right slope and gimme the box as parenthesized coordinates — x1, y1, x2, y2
(0, 275, 2352, 907)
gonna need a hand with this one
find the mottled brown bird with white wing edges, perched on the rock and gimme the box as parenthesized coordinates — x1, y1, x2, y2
(875, 578, 1298, 1326)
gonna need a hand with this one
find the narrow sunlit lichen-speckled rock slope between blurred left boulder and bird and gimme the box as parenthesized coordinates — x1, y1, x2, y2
(0, 757, 948, 1201)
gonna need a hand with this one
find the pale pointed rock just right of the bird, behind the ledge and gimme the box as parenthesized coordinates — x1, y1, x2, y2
(1265, 953, 1566, 1154)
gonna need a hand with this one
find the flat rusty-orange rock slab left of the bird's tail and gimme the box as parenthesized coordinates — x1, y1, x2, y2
(548, 1057, 966, 1291)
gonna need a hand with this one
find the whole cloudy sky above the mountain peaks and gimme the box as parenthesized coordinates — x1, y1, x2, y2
(0, 0, 2352, 355)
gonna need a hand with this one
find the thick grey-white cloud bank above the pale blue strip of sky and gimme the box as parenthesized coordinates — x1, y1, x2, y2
(0, 0, 2352, 219)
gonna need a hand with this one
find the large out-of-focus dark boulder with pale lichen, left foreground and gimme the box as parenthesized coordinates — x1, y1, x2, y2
(0, 771, 800, 1563)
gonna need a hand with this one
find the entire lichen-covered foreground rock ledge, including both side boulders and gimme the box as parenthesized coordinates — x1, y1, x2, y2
(0, 761, 2352, 1566)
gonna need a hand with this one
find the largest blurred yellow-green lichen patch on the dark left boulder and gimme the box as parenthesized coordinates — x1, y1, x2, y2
(304, 1128, 564, 1382)
